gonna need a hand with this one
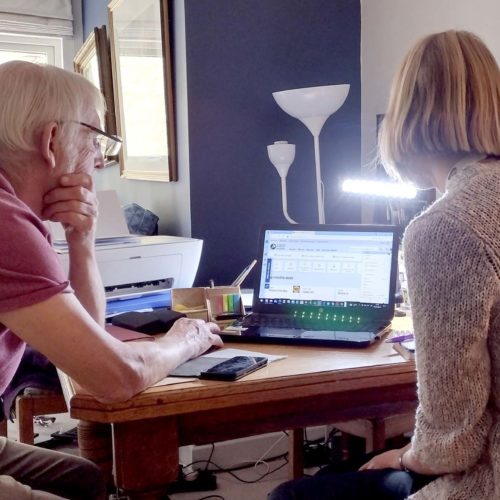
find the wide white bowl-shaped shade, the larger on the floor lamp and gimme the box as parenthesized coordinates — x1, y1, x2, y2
(273, 84, 350, 135)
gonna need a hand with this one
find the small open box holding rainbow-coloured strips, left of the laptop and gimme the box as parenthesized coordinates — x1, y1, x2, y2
(205, 286, 245, 326)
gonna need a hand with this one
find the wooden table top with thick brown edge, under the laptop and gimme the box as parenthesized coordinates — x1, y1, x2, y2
(64, 318, 416, 422)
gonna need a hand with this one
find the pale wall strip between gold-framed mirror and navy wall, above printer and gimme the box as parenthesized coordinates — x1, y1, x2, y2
(94, 0, 191, 236)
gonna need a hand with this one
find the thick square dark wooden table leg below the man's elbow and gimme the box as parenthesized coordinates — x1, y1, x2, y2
(113, 417, 179, 500)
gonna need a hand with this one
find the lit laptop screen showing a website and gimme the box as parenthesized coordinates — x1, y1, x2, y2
(258, 229, 395, 309)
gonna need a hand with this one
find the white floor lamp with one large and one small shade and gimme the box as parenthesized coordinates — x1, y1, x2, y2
(268, 84, 350, 224)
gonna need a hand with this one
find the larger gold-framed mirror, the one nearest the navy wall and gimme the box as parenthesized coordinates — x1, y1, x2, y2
(108, 0, 177, 181)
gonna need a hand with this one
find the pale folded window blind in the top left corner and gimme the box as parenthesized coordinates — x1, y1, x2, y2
(0, 0, 73, 36)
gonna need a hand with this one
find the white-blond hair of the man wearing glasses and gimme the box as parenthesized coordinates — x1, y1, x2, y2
(0, 61, 104, 165)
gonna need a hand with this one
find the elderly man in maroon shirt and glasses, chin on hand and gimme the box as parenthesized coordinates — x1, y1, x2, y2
(0, 61, 222, 499)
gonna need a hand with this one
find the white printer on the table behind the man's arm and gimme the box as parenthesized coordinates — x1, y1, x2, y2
(49, 191, 203, 300)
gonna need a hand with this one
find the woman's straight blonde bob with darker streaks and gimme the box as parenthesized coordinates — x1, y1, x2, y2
(379, 31, 500, 180)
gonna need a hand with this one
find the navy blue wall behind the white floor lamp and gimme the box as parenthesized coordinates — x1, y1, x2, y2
(83, 0, 361, 285)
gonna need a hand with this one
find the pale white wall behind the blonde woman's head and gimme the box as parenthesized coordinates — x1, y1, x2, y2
(361, 0, 500, 182)
